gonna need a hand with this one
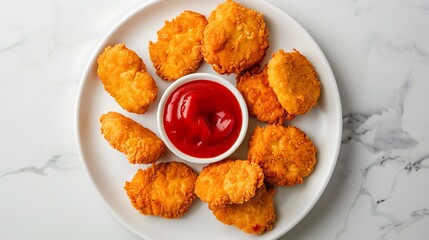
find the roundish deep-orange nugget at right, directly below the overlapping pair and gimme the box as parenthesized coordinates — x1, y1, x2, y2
(247, 125, 317, 186)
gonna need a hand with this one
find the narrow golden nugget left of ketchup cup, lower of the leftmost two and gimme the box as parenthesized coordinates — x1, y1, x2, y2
(100, 112, 166, 164)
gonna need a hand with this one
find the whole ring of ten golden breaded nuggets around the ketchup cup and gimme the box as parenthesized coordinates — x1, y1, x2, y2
(97, 0, 321, 234)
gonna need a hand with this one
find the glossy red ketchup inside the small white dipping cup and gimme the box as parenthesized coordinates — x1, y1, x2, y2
(163, 80, 242, 158)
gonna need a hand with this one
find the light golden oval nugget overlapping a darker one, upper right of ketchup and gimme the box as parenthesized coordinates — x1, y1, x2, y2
(267, 49, 321, 117)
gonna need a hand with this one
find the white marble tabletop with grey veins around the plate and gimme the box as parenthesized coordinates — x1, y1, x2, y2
(0, 0, 429, 240)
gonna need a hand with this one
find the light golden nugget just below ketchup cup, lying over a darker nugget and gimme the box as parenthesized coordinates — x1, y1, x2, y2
(195, 159, 264, 206)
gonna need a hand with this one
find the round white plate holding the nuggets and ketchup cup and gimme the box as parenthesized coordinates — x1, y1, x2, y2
(75, 0, 342, 240)
